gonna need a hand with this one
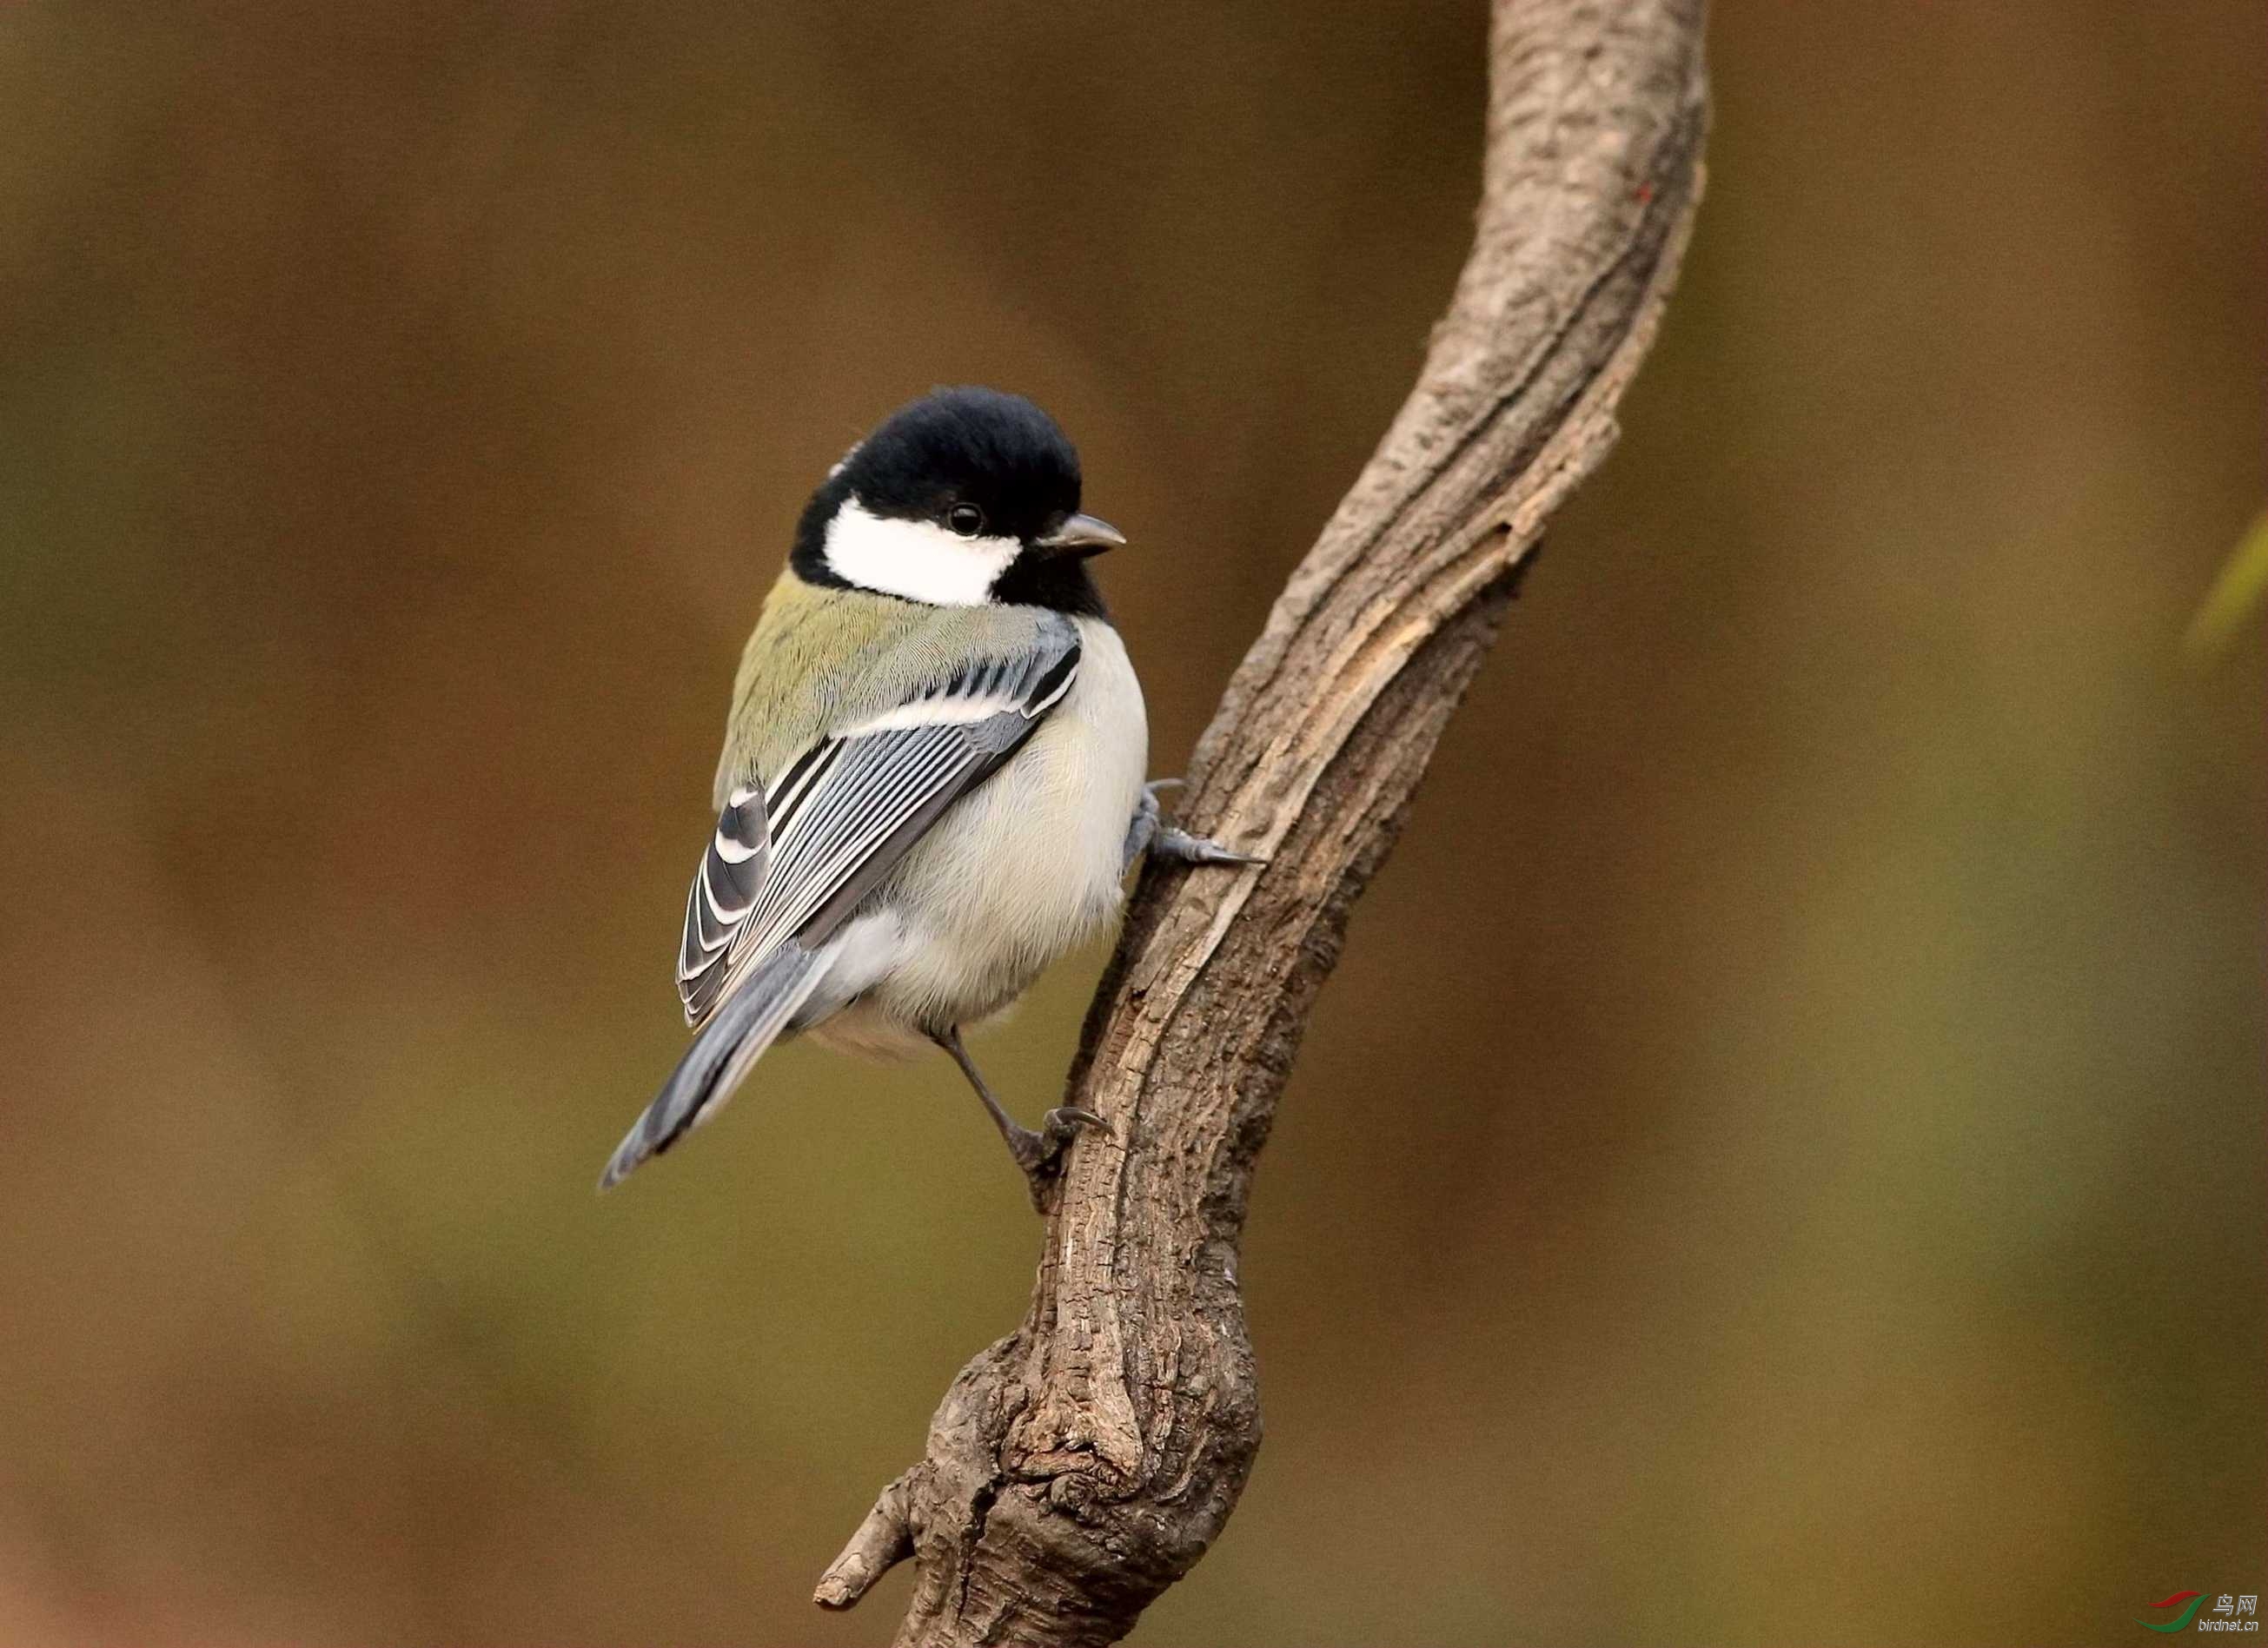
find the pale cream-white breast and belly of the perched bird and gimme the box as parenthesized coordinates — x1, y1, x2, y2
(810, 619, 1150, 1054)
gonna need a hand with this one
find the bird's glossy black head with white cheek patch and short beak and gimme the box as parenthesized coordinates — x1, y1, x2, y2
(789, 387, 1125, 617)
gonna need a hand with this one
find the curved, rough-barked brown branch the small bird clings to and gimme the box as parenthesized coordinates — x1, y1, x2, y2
(817, 0, 1706, 1648)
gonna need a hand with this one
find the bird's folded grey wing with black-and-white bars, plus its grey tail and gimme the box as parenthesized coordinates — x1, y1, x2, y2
(601, 621, 1079, 1186)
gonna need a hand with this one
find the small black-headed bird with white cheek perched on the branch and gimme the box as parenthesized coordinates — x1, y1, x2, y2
(599, 386, 1263, 1204)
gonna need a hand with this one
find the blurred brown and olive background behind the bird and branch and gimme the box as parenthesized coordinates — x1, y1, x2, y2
(0, 0, 2268, 1648)
